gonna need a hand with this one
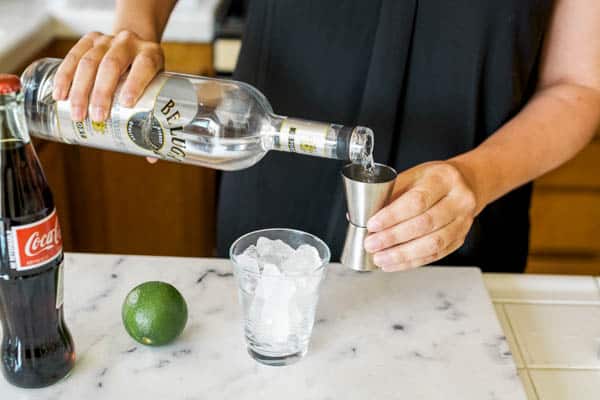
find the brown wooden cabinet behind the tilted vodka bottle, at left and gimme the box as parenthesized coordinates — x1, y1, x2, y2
(25, 40, 216, 256)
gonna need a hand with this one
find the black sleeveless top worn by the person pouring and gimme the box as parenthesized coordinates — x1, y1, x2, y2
(217, 0, 553, 272)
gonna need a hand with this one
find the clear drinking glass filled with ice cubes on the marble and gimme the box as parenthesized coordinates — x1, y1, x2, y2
(229, 229, 330, 365)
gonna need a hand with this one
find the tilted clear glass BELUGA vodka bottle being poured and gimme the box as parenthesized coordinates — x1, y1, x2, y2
(21, 58, 373, 170)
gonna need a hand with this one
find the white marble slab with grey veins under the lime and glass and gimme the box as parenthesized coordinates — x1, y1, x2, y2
(0, 254, 526, 400)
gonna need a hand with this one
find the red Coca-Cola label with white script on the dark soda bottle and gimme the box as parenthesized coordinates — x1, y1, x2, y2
(12, 210, 62, 270)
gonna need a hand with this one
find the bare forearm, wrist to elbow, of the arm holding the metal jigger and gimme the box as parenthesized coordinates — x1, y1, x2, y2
(450, 83, 600, 216)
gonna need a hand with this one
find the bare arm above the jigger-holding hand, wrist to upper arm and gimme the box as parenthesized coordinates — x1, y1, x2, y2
(450, 0, 600, 216)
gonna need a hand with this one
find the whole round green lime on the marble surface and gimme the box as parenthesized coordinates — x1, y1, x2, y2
(121, 282, 187, 346)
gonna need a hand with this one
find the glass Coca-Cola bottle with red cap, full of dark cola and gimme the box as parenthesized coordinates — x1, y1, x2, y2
(0, 74, 75, 388)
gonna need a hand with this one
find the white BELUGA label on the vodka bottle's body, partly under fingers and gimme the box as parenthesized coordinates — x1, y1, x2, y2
(56, 74, 198, 161)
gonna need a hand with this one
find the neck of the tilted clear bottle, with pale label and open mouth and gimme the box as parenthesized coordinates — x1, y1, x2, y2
(265, 116, 373, 162)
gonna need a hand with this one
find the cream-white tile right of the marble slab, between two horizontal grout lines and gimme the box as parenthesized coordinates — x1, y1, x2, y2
(504, 304, 600, 368)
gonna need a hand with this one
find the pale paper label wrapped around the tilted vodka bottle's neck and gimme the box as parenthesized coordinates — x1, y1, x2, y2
(275, 118, 335, 157)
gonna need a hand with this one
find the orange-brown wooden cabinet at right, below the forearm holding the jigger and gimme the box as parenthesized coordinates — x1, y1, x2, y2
(527, 137, 600, 275)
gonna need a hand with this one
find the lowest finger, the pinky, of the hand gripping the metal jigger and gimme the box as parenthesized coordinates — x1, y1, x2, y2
(373, 217, 471, 271)
